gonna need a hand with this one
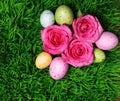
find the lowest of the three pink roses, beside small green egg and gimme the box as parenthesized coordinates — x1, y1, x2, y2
(62, 39, 94, 67)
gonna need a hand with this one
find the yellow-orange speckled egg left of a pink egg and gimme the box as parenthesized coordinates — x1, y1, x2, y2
(35, 52, 52, 69)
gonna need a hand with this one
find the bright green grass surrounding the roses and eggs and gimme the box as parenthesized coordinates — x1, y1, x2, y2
(0, 0, 120, 101)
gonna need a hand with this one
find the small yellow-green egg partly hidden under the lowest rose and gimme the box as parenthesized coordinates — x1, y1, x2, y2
(93, 48, 106, 63)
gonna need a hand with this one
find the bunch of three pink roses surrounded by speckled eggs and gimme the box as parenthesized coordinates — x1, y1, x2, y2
(40, 14, 103, 67)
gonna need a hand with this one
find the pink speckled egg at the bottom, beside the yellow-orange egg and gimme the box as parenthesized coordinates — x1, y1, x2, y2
(49, 57, 68, 80)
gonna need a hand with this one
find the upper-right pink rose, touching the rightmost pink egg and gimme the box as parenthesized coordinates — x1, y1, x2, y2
(72, 14, 103, 43)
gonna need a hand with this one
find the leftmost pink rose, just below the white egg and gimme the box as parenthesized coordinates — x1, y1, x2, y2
(41, 25, 72, 55)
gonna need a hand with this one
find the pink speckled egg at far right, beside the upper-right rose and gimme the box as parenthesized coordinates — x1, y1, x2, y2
(95, 32, 118, 50)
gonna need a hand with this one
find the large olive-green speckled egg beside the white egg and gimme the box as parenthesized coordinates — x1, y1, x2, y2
(55, 5, 74, 25)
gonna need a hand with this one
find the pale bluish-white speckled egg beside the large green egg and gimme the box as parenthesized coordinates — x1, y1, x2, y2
(40, 10, 55, 27)
